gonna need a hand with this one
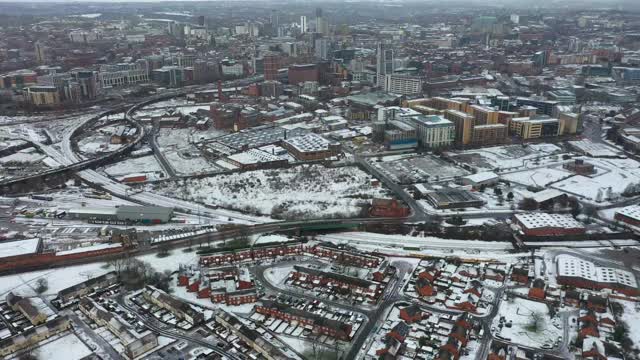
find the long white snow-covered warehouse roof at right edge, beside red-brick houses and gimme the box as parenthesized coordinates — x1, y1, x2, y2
(556, 255, 638, 288)
